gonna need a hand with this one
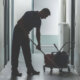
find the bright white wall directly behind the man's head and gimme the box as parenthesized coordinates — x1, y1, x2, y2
(34, 0, 59, 35)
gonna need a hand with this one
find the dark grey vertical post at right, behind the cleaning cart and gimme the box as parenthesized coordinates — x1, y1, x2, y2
(71, 0, 75, 65)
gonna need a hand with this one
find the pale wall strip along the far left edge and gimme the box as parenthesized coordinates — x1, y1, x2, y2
(0, 0, 4, 71)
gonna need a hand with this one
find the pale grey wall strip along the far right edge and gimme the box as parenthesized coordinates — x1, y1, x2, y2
(74, 0, 80, 74)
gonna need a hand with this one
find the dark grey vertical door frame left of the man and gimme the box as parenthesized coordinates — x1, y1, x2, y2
(3, 0, 9, 65)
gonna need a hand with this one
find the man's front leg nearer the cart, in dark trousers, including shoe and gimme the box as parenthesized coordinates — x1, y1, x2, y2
(21, 35, 39, 75)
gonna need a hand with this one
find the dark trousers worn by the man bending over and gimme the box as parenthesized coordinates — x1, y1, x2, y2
(11, 25, 33, 72)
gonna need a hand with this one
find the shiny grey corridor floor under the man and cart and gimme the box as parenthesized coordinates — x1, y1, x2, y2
(0, 54, 80, 80)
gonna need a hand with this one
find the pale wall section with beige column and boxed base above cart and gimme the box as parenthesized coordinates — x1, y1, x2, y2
(59, 0, 71, 52)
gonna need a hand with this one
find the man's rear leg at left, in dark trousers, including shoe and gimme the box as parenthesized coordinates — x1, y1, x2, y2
(11, 28, 21, 76)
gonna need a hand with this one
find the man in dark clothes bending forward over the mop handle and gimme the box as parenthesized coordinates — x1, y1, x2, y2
(11, 8, 50, 76)
